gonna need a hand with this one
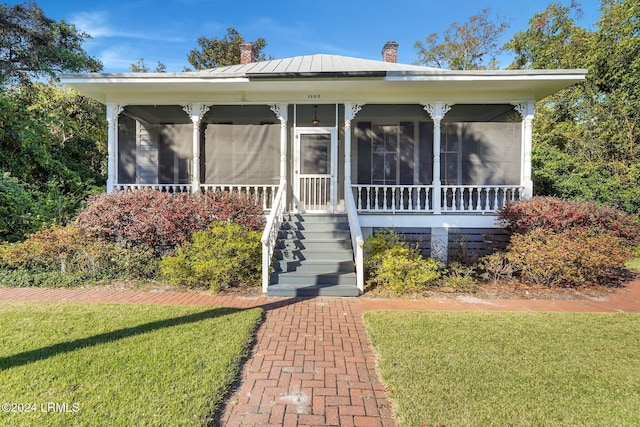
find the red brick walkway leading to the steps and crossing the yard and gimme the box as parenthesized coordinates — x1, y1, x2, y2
(0, 280, 640, 426)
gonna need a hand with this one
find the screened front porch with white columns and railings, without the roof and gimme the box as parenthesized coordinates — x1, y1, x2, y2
(108, 102, 532, 292)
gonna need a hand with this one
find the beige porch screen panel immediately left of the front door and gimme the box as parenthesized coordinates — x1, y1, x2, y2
(203, 124, 280, 185)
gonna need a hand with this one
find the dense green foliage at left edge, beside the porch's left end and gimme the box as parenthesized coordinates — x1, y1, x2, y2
(0, 83, 107, 241)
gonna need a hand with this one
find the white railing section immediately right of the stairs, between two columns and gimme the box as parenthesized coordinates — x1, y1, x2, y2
(352, 185, 433, 212)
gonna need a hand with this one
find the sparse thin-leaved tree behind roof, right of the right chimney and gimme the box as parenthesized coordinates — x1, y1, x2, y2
(414, 9, 509, 70)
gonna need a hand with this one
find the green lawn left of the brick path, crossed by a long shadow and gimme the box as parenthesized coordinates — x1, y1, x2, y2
(0, 303, 262, 426)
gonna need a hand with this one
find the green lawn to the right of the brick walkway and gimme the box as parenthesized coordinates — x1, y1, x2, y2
(365, 312, 640, 426)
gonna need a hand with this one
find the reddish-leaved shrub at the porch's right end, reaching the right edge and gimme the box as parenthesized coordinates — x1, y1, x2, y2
(499, 196, 640, 247)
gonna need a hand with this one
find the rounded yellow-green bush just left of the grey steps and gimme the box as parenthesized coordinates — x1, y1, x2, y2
(160, 221, 262, 290)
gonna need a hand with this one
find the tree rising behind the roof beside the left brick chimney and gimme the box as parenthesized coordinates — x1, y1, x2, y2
(187, 27, 267, 70)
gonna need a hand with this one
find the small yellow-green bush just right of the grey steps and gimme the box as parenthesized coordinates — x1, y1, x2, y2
(371, 246, 440, 294)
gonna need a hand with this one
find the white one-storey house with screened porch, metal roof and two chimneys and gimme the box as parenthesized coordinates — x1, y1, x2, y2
(62, 42, 586, 295)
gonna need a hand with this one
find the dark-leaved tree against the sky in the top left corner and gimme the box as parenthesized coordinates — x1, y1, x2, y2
(0, 2, 102, 85)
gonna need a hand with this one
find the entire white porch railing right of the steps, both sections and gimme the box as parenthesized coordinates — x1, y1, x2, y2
(351, 184, 524, 213)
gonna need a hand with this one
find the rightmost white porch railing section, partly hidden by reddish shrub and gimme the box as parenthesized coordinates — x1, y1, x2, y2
(442, 185, 524, 213)
